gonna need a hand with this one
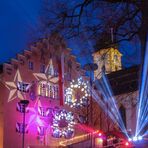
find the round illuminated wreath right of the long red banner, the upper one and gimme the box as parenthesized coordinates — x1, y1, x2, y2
(65, 78, 90, 107)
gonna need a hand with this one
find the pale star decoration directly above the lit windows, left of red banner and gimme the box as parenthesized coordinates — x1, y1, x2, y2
(33, 59, 58, 83)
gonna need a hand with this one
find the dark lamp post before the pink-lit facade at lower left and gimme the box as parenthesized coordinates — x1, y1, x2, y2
(20, 100, 29, 148)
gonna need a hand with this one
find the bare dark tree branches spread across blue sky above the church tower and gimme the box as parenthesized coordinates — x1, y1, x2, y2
(42, 0, 148, 63)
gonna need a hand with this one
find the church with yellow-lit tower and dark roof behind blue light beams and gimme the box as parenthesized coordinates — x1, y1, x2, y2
(93, 48, 139, 140)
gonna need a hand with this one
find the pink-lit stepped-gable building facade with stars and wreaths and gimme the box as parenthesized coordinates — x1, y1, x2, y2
(0, 35, 100, 148)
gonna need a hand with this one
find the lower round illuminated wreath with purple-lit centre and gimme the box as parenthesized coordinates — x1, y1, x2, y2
(52, 110, 75, 138)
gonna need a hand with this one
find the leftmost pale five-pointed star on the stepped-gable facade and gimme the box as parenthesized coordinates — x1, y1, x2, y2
(5, 70, 24, 102)
